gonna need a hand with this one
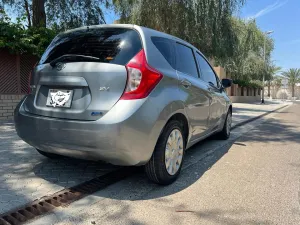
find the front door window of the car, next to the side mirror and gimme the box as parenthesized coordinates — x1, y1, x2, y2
(196, 53, 219, 87)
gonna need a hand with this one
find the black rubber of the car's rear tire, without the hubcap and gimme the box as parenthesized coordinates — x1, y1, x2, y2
(145, 120, 186, 185)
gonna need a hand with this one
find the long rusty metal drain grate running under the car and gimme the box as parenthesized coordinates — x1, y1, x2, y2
(0, 167, 136, 225)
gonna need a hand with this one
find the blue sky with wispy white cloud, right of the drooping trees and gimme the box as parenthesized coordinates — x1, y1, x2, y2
(240, 0, 300, 70)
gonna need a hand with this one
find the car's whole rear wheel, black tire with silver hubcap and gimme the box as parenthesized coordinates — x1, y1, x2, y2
(145, 121, 186, 185)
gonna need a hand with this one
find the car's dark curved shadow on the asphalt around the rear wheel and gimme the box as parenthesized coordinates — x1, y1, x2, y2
(99, 137, 233, 201)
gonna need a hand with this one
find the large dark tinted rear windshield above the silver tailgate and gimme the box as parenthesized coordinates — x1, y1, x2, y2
(40, 28, 142, 65)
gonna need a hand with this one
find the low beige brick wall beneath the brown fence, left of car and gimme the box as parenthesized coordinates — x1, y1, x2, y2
(0, 95, 24, 120)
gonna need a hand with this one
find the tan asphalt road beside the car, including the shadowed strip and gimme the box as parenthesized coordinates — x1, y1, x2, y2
(32, 103, 300, 225)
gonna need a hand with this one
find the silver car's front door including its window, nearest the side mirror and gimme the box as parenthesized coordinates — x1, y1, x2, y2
(196, 52, 226, 131)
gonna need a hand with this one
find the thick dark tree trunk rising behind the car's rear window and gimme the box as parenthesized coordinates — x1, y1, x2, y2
(32, 0, 46, 27)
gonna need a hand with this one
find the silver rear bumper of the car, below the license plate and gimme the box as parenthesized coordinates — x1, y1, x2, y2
(15, 96, 163, 165)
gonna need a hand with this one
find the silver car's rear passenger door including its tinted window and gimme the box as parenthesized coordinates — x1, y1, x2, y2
(176, 43, 210, 141)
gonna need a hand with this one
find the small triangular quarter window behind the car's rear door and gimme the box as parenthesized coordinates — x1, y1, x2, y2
(151, 37, 176, 69)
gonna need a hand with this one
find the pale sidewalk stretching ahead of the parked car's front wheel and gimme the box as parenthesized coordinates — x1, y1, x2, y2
(232, 101, 292, 128)
